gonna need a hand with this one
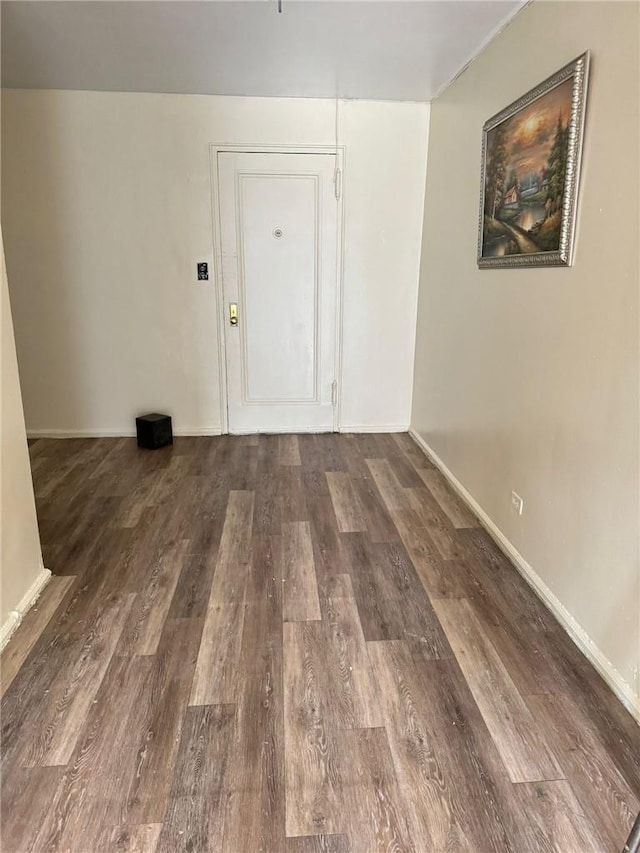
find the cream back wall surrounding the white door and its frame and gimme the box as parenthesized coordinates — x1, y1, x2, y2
(2, 90, 429, 435)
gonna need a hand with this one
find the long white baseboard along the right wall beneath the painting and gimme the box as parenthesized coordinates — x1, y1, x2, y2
(409, 428, 640, 722)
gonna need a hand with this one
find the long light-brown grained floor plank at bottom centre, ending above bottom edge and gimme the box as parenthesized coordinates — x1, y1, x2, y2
(283, 622, 344, 836)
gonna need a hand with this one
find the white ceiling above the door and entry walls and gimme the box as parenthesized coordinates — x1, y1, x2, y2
(2, 0, 524, 101)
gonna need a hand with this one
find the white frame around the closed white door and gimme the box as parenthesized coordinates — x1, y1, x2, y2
(209, 142, 346, 435)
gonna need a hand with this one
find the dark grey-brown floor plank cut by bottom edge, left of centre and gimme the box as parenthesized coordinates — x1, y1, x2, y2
(156, 705, 235, 853)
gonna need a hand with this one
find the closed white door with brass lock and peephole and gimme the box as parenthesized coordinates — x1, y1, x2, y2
(218, 152, 337, 433)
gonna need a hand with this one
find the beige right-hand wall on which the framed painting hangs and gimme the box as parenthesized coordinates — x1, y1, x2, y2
(412, 2, 640, 708)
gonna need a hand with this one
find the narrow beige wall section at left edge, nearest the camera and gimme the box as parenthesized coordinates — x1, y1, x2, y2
(0, 230, 48, 646)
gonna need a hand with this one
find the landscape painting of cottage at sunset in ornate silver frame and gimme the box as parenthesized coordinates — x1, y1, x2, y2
(478, 52, 589, 269)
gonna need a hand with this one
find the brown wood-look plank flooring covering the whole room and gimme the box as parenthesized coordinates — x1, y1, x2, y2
(2, 435, 640, 853)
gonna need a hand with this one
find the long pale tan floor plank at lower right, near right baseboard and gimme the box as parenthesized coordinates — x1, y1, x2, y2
(433, 599, 565, 782)
